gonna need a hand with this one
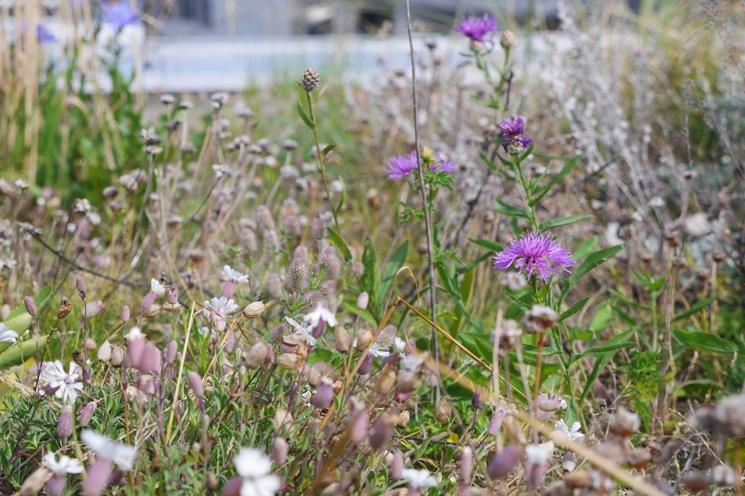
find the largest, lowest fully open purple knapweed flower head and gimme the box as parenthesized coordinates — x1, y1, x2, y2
(494, 233, 574, 282)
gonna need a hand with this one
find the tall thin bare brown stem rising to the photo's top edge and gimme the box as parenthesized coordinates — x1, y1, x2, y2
(406, 0, 440, 403)
